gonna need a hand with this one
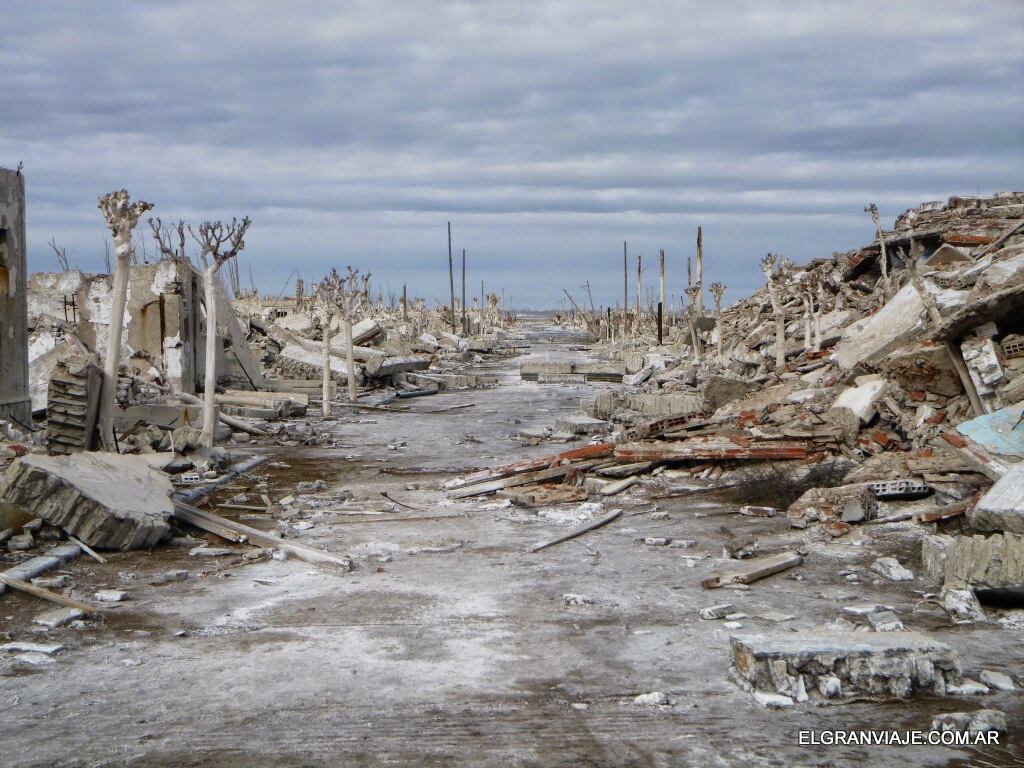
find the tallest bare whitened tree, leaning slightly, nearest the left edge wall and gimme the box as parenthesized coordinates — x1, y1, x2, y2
(97, 189, 153, 451)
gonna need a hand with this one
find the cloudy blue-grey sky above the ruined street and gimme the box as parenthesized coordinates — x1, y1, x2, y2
(0, 0, 1024, 308)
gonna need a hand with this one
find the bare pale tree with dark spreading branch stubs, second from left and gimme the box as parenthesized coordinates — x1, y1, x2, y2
(188, 216, 252, 447)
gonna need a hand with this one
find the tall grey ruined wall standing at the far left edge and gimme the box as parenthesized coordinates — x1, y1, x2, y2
(0, 168, 32, 424)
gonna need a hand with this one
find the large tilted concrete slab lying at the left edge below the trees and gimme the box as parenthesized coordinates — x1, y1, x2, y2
(0, 454, 173, 550)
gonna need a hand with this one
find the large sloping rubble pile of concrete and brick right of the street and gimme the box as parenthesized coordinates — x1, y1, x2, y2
(501, 193, 1024, 529)
